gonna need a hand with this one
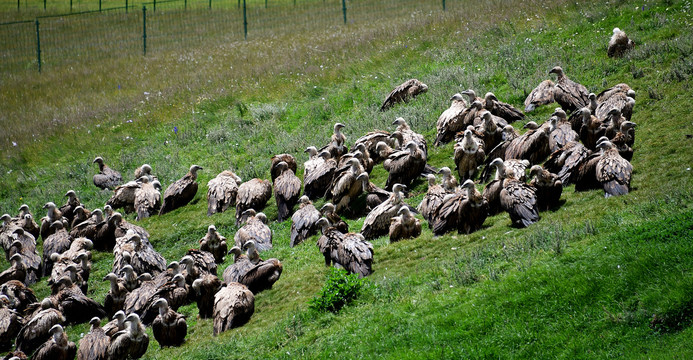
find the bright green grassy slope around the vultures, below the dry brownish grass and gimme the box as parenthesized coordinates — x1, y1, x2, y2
(0, 3, 693, 358)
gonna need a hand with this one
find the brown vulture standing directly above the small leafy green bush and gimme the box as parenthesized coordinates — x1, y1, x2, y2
(317, 218, 373, 278)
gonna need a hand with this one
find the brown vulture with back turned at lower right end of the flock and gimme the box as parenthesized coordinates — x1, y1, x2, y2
(595, 141, 633, 198)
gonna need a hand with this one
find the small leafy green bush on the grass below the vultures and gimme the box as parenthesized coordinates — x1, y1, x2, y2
(310, 268, 365, 312)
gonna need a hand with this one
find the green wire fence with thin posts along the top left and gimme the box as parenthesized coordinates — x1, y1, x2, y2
(0, 0, 449, 73)
